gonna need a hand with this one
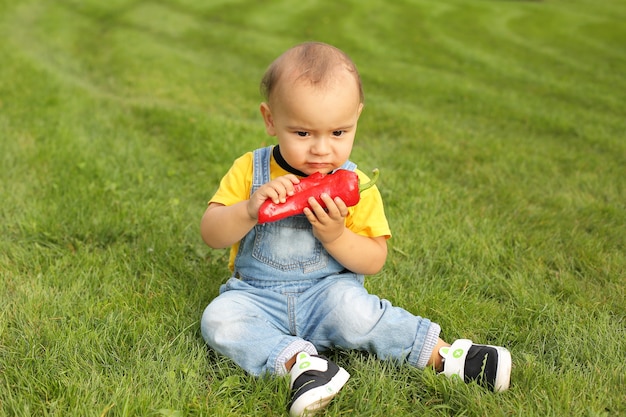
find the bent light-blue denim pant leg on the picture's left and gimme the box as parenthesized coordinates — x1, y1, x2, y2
(200, 278, 317, 376)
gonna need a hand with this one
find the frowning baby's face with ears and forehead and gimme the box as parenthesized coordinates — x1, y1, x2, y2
(261, 70, 363, 175)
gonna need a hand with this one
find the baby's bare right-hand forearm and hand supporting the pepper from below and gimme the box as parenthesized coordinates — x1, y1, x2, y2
(304, 194, 387, 275)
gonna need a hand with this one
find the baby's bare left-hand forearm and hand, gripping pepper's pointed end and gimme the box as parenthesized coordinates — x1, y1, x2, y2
(200, 174, 300, 249)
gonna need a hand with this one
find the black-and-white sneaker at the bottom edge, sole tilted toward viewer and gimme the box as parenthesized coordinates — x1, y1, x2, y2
(289, 352, 350, 417)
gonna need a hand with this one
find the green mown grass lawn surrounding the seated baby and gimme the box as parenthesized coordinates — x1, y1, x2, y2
(0, 0, 626, 416)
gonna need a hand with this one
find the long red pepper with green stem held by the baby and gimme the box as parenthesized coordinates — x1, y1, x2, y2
(259, 169, 379, 223)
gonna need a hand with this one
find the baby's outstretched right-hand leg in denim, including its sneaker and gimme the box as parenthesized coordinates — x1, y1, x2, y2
(297, 274, 511, 391)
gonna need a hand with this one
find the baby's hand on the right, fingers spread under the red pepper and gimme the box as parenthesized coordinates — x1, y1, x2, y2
(304, 194, 348, 244)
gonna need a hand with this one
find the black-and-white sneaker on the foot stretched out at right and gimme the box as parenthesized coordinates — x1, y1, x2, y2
(439, 339, 511, 391)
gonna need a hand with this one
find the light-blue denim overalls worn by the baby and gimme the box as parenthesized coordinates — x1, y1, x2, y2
(201, 147, 440, 375)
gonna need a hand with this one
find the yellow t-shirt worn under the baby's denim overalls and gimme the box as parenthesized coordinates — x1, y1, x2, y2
(209, 152, 391, 271)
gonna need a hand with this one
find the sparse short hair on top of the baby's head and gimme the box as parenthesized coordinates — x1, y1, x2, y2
(261, 42, 364, 102)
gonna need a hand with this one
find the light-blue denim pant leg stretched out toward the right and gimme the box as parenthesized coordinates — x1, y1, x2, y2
(296, 274, 440, 368)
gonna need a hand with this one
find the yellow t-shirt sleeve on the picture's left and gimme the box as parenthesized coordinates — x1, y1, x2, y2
(209, 152, 252, 206)
